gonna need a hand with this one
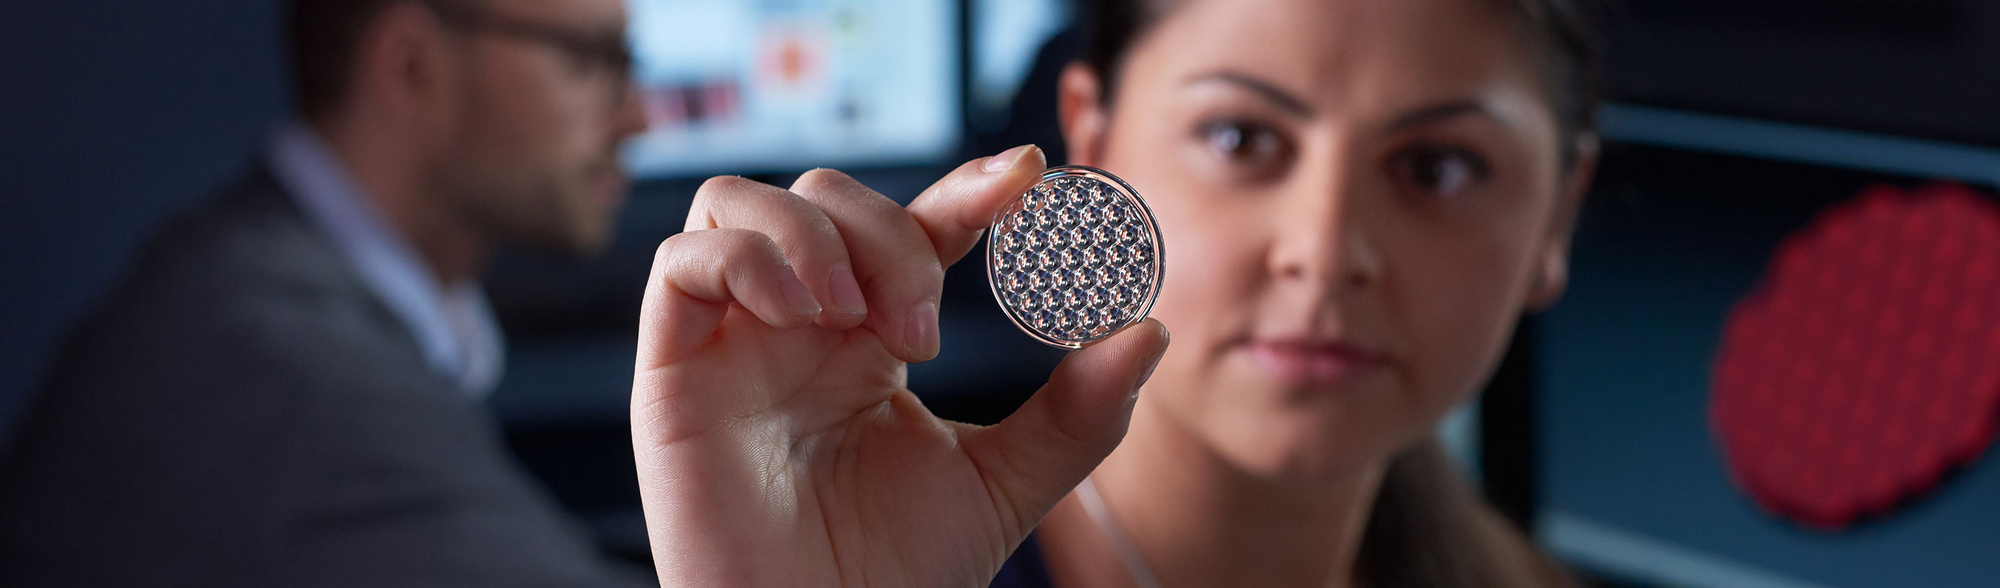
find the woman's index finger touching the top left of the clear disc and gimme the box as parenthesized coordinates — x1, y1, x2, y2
(908, 144, 1048, 266)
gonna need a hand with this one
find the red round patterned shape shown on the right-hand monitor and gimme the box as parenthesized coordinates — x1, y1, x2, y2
(1708, 186, 2000, 530)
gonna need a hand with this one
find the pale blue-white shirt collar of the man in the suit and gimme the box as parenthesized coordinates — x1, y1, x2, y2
(268, 122, 506, 396)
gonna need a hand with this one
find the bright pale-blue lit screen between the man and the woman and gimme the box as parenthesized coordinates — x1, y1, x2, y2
(624, 0, 962, 178)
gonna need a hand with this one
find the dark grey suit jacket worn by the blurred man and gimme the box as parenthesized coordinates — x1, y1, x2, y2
(0, 170, 648, 586)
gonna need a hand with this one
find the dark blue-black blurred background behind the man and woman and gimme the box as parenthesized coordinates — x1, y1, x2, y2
(0, 0, 2000, 586)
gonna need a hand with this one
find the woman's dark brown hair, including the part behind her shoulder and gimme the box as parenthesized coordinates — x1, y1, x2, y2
(1082, 0, 1602, 588)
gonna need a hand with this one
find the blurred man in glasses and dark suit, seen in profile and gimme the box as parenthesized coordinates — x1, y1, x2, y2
(0, 0, 644, 586)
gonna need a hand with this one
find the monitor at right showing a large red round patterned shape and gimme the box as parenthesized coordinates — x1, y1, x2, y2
(1532, 104, 2000, 588)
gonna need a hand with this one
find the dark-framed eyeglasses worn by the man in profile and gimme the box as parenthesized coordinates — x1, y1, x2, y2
(422, 0, 634, 104)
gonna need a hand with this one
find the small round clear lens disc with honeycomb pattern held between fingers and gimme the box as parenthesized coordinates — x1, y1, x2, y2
(986, 166, 1162, 348)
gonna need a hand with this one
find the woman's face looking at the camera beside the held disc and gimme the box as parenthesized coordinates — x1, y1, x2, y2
(1062, 0, 1592, 476)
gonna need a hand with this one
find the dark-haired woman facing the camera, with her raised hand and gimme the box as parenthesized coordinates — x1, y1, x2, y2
(632, 0, 1596, 586)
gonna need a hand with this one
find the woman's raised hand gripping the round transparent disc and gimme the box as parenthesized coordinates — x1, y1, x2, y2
(632, 148, 1166, 588)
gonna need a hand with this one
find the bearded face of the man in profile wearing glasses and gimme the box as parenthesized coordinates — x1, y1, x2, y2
(428, 0, 646, 256)
